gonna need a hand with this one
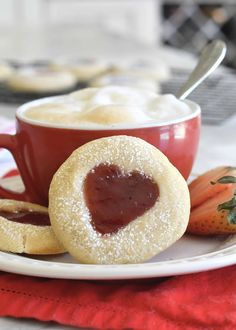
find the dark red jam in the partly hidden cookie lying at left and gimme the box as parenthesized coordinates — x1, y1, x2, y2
(0, 209, 51, 226)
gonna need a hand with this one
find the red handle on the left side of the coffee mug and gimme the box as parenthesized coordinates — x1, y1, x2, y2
(0, 134, 37, 202)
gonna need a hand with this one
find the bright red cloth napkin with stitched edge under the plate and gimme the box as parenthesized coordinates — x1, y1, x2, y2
(0, 171, 236, 330)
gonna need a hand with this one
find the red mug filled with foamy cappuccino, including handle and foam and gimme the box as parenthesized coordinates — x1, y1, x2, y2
(0, 86, 201, 205)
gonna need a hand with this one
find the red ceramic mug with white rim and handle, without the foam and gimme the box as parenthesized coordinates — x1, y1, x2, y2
(0, 98, 200, 205)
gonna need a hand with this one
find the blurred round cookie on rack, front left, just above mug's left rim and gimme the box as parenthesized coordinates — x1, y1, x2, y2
(7, 67, 77, 94)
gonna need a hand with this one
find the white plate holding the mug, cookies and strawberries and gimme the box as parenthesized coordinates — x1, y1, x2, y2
(0, 178, 236, 280)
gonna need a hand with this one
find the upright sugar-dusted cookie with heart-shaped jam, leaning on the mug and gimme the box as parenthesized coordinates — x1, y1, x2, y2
(49, 136, 190, 264)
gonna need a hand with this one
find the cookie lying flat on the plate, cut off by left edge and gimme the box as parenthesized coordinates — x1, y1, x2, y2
(0, 199, 65, 254)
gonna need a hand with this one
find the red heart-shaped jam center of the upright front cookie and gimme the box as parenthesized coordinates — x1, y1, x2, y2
(84, 163, 159, 234)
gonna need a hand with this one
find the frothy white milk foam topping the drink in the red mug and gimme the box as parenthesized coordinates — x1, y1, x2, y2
(21, 86, 197, 128)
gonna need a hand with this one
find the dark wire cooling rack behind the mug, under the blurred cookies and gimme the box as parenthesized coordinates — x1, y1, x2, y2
(0, 65, 236, 125)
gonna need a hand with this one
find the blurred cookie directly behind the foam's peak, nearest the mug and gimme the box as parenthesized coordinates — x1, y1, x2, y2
(89, 73, 161, 93)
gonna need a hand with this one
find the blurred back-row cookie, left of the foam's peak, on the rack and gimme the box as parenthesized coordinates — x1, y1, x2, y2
(50, 58, 110, 82)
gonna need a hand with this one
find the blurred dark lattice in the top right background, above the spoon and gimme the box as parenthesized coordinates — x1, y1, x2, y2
(162, 0, 236, 67)
